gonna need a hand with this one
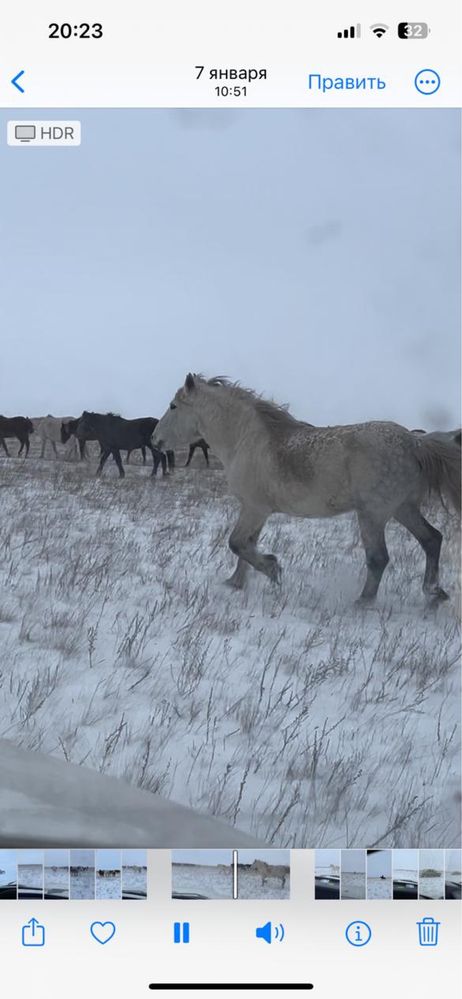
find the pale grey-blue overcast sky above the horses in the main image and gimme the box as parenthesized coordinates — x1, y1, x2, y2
(0, 110, 460, 428)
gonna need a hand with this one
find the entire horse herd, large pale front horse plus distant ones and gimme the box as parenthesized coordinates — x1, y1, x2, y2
(0, 374, 461, 604)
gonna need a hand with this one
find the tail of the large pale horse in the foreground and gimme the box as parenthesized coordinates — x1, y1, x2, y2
(417, 432, 461, 516)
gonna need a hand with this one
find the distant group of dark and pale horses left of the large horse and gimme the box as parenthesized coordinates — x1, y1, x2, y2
(0, 410, 210, 478)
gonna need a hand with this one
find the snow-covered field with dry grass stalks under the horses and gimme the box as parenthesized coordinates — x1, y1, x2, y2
(0, 438, 459, 847)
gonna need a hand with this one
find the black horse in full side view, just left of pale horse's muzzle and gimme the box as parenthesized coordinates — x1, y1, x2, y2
(76, 410, 167, 479)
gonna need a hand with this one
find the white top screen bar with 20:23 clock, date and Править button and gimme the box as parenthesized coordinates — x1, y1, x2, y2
(0, 0, 462, 109)
